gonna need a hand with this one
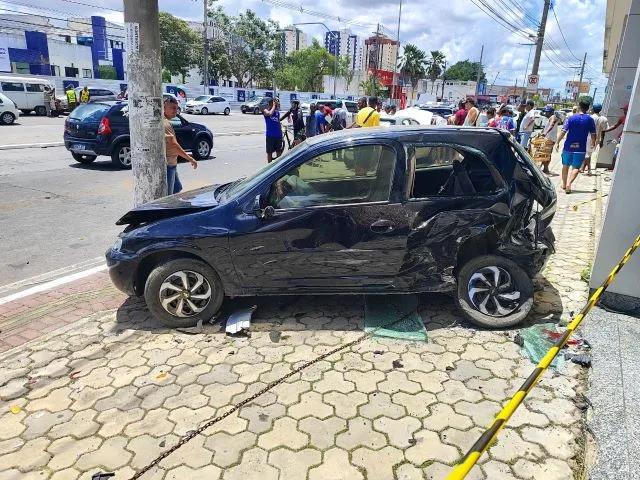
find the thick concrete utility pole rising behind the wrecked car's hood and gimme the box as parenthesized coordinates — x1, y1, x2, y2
(124, 0, 167, 206)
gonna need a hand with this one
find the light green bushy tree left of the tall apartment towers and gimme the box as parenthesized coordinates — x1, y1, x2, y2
(274, 39, 336, 92)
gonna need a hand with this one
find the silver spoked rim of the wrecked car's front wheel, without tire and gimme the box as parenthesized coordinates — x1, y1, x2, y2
(159, 270, 211, 318)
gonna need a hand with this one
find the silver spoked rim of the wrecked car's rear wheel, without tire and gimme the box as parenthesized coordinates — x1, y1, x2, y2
(468, 265, 520, 317)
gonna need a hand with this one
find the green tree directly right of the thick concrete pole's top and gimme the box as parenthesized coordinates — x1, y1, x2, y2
(159, 12, 202, 83)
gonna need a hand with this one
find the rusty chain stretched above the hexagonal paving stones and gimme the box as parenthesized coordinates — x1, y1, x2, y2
(129, 310, 413, 480)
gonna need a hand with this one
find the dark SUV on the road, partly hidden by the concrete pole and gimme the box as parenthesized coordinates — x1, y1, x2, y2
(64, 102, 213, 168)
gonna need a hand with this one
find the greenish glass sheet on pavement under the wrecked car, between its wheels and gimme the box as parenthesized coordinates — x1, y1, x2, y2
(364, 295, 427, 342)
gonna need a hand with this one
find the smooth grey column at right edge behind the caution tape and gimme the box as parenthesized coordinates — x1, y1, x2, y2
(590, 57, 640, 310)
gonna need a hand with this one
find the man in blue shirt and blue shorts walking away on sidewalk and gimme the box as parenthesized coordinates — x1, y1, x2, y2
(556, 101, 596, 193)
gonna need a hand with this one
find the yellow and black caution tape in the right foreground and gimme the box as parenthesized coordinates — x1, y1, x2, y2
(447, 231, 640, 480)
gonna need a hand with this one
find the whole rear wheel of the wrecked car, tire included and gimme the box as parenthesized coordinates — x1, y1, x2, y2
(456, 255, 533, 328)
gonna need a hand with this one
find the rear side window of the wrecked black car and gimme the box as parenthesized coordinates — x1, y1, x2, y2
(409, 146, 502, 199)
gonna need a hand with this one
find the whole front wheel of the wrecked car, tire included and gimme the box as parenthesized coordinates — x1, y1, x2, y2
(144, 258, 224, 328)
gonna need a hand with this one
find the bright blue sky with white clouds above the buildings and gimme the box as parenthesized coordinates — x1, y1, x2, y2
(0, 0, 606, 99)
